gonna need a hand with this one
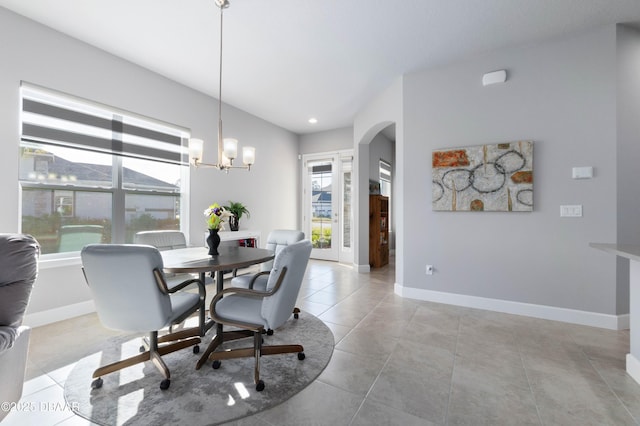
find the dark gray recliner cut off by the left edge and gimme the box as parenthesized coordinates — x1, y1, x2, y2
(0, 234, 40, 421)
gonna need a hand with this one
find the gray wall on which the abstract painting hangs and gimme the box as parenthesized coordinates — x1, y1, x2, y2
(397, 26, 624, 314)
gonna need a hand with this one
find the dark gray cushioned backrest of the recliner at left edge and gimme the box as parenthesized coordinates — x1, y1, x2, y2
(0, 234, 40, 328)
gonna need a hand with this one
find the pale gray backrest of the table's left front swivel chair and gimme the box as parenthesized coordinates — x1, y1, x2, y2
(80, 244, 171, 332)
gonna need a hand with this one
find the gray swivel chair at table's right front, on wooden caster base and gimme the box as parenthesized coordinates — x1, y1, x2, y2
(209, 240, 311, 391)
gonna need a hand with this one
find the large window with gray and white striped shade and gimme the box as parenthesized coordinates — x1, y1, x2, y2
(19, 83, 189, 254)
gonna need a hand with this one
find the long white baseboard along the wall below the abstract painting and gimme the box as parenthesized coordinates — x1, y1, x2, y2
(394, 283, 628, 332)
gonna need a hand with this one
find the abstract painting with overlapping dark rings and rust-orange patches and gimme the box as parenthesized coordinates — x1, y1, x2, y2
(431, 141, 533, 212)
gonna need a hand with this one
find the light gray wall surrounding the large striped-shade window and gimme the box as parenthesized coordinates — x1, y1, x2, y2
(0, 8, 300, 322)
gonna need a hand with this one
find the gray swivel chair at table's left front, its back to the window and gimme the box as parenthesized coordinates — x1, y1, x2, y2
(80, 244, 205, 390)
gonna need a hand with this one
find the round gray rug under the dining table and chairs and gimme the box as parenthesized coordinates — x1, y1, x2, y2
(64, 312, 334, 425)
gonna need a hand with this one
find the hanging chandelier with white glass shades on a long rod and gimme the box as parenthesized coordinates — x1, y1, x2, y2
(189, 0, 256, 173)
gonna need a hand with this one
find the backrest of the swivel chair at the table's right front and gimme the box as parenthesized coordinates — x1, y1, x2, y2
(261, 240, 311, 330)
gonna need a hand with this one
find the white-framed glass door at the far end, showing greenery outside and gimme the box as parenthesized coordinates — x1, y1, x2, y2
(302, 153, 353, 261)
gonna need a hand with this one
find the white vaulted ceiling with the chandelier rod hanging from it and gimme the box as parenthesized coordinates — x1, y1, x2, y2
(0, 0, 640, 133)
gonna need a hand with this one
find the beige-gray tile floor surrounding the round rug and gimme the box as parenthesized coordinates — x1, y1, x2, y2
(2, 261, 640, 426)
